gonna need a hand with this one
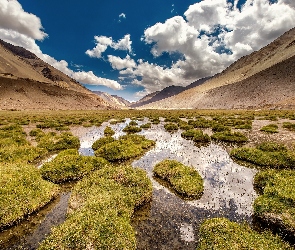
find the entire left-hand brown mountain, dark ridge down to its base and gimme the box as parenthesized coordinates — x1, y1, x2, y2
(0, 40, 115, 110)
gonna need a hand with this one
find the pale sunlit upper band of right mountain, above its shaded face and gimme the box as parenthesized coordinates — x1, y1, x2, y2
(141, 28, 295, 108)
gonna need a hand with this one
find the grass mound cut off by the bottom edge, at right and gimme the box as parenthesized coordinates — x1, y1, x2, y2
(197, 218, 293, 250)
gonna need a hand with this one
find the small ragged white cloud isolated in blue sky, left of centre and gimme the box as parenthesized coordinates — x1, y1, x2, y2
(85, 34, 132, 58)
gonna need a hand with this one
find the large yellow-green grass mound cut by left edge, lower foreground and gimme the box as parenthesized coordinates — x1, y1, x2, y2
(0, 163, 58, 228)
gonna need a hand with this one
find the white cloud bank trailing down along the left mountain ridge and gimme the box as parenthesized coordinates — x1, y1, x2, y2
(0, 0, 122, 90)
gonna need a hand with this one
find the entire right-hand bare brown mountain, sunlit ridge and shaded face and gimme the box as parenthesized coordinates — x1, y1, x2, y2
(140, 28, 295, 109)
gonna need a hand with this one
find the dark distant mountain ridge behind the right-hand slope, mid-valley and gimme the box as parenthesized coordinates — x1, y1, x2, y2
(131, 77, 210, 108)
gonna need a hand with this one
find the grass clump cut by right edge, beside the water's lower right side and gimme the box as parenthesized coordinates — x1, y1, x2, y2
(254, 169, 295, 234)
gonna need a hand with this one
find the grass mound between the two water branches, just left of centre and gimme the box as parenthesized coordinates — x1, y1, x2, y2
(95, 135, 155, 162)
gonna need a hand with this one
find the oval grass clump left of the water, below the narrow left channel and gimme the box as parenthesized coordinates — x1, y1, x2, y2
(41, 149, 108, 183)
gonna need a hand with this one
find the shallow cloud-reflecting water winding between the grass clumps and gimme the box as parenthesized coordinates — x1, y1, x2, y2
(72, 119, 257, 249)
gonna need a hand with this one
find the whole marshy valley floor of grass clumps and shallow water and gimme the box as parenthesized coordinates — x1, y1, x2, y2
(0, 110, 295, 249)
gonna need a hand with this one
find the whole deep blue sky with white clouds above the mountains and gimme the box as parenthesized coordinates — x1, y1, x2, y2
(0, 0, 295, 101)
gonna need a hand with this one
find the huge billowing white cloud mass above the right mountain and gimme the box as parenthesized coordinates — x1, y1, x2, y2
(131, 0, 295, 92)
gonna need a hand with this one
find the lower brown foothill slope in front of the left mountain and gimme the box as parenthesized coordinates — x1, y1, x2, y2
(0, 77, 111, 110)
